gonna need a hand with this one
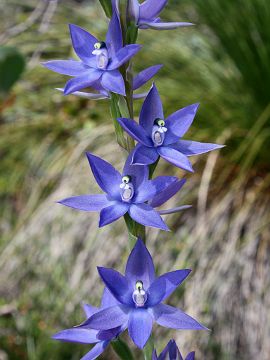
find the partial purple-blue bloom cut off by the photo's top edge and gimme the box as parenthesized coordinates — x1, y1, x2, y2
(112, 0, 193, 30)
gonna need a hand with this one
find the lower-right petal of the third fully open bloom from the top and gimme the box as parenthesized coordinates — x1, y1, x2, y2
(128, 204, 169, 231)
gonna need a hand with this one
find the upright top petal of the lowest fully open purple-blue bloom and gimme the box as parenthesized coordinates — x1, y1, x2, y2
(125, 239, 155, 289)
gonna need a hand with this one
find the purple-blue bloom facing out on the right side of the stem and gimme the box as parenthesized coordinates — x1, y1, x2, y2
(117, 84, 223, 172)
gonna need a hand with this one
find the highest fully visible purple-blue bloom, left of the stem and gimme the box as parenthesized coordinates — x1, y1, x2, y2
(43, 12, 141, 95)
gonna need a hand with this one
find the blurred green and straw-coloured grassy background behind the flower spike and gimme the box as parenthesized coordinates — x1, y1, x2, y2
(0, 0, 270, 360)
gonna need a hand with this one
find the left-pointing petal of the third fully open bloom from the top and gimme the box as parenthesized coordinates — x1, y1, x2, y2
(59, 194, 110, 211)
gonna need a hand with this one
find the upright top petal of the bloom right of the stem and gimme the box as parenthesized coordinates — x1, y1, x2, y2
(140, 84, 164, 136)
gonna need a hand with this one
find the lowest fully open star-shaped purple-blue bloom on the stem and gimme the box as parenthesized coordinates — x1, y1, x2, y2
(80, 239, 206, 348)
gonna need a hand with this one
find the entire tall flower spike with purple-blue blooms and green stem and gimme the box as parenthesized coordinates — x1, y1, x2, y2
(44, 0, 224, 360)
